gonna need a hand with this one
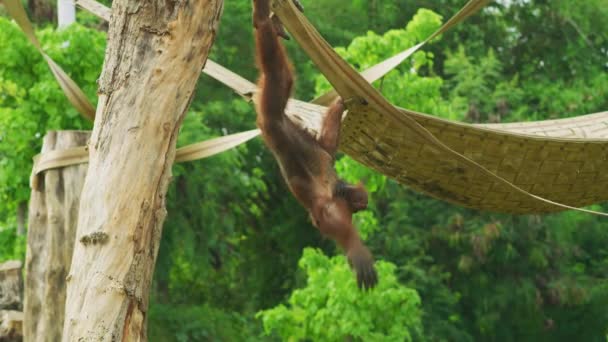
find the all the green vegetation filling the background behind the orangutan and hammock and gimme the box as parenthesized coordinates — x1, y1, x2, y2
(0, 0, 608, 341)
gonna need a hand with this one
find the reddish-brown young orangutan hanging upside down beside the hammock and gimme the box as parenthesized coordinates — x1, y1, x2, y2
(253, 0, 377, 288)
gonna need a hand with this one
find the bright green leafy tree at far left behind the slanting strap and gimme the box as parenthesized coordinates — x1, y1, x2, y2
(0, 18, 105, 228)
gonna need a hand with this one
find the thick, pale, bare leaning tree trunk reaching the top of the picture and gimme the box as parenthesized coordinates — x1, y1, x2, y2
(63, 0, 223, 341)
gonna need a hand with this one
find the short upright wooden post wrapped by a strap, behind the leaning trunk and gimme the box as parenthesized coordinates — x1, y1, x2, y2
(23, 131, 90, 342)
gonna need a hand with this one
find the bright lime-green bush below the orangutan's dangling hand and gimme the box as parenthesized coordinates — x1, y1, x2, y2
(258, 248, 422, 341)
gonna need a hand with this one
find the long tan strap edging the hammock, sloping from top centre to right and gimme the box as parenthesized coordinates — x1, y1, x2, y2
(272, 0, 608, 216)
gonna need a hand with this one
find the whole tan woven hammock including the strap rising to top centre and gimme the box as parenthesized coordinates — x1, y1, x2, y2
(273, 0, 608, 214)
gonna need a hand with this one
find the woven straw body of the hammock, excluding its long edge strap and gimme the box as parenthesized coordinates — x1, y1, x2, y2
(341, 109, 608, 213)
